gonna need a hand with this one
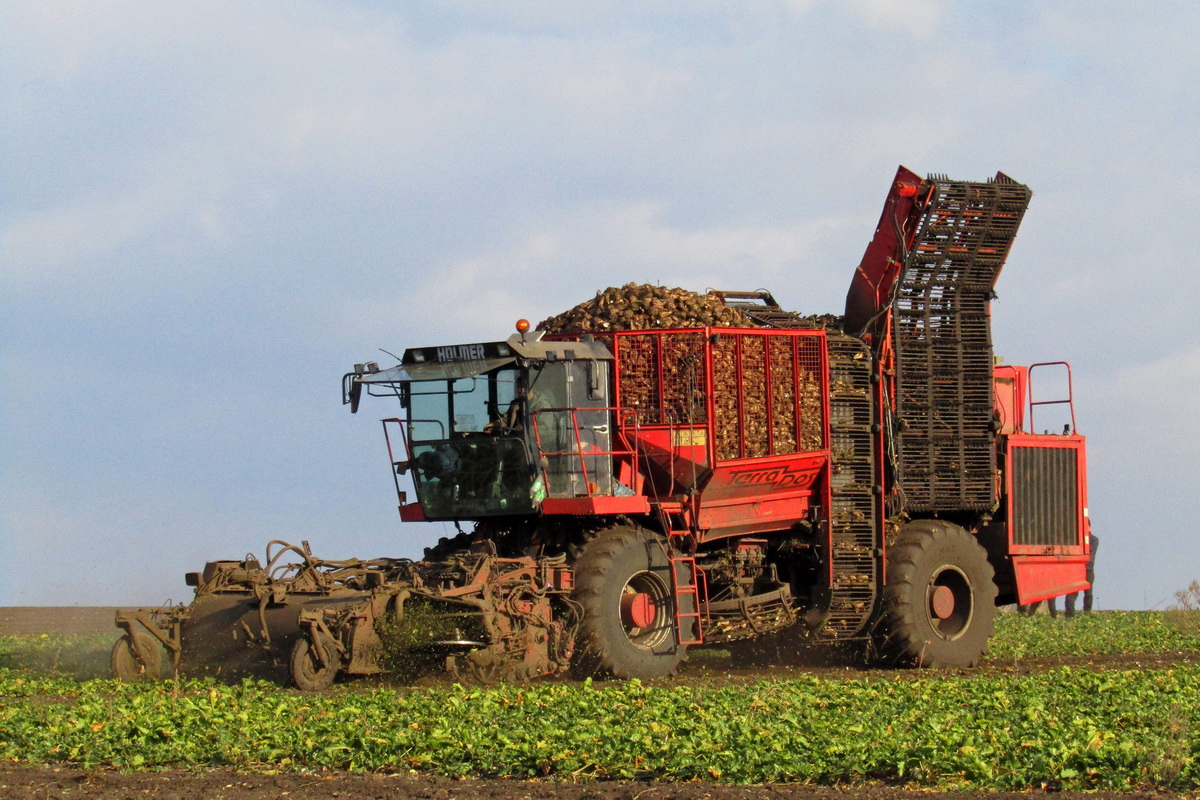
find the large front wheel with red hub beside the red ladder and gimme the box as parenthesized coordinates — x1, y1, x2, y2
(572, 525, 684, 680)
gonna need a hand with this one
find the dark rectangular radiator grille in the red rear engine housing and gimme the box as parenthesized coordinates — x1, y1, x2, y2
(1013, 447, 1080, 546)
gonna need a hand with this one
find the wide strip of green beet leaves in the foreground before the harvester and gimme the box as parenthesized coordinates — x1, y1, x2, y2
(0, 667, 1200, 790)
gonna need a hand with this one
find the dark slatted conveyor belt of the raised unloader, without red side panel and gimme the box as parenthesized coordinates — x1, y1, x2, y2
(892, 176, 1031, 511)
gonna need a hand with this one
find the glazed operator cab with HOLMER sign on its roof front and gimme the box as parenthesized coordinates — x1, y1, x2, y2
(342, 327, 613, 519)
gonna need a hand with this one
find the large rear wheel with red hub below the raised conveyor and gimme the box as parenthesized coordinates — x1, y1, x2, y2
(878, 519, 996, 669)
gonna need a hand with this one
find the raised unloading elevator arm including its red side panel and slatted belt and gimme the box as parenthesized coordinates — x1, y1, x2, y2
(846, 168, 1032, 513)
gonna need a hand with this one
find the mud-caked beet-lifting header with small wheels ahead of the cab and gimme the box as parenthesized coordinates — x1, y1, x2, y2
(113, 541, 577, 691)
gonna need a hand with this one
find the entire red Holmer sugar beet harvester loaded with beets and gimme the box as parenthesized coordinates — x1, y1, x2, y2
(113, 168, 1088, 688)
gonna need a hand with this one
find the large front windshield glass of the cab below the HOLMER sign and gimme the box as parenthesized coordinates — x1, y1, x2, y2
(403, 368, 534, 519)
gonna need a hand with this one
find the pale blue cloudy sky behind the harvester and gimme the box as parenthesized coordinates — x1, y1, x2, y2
(0, 0, 1200, 608)
